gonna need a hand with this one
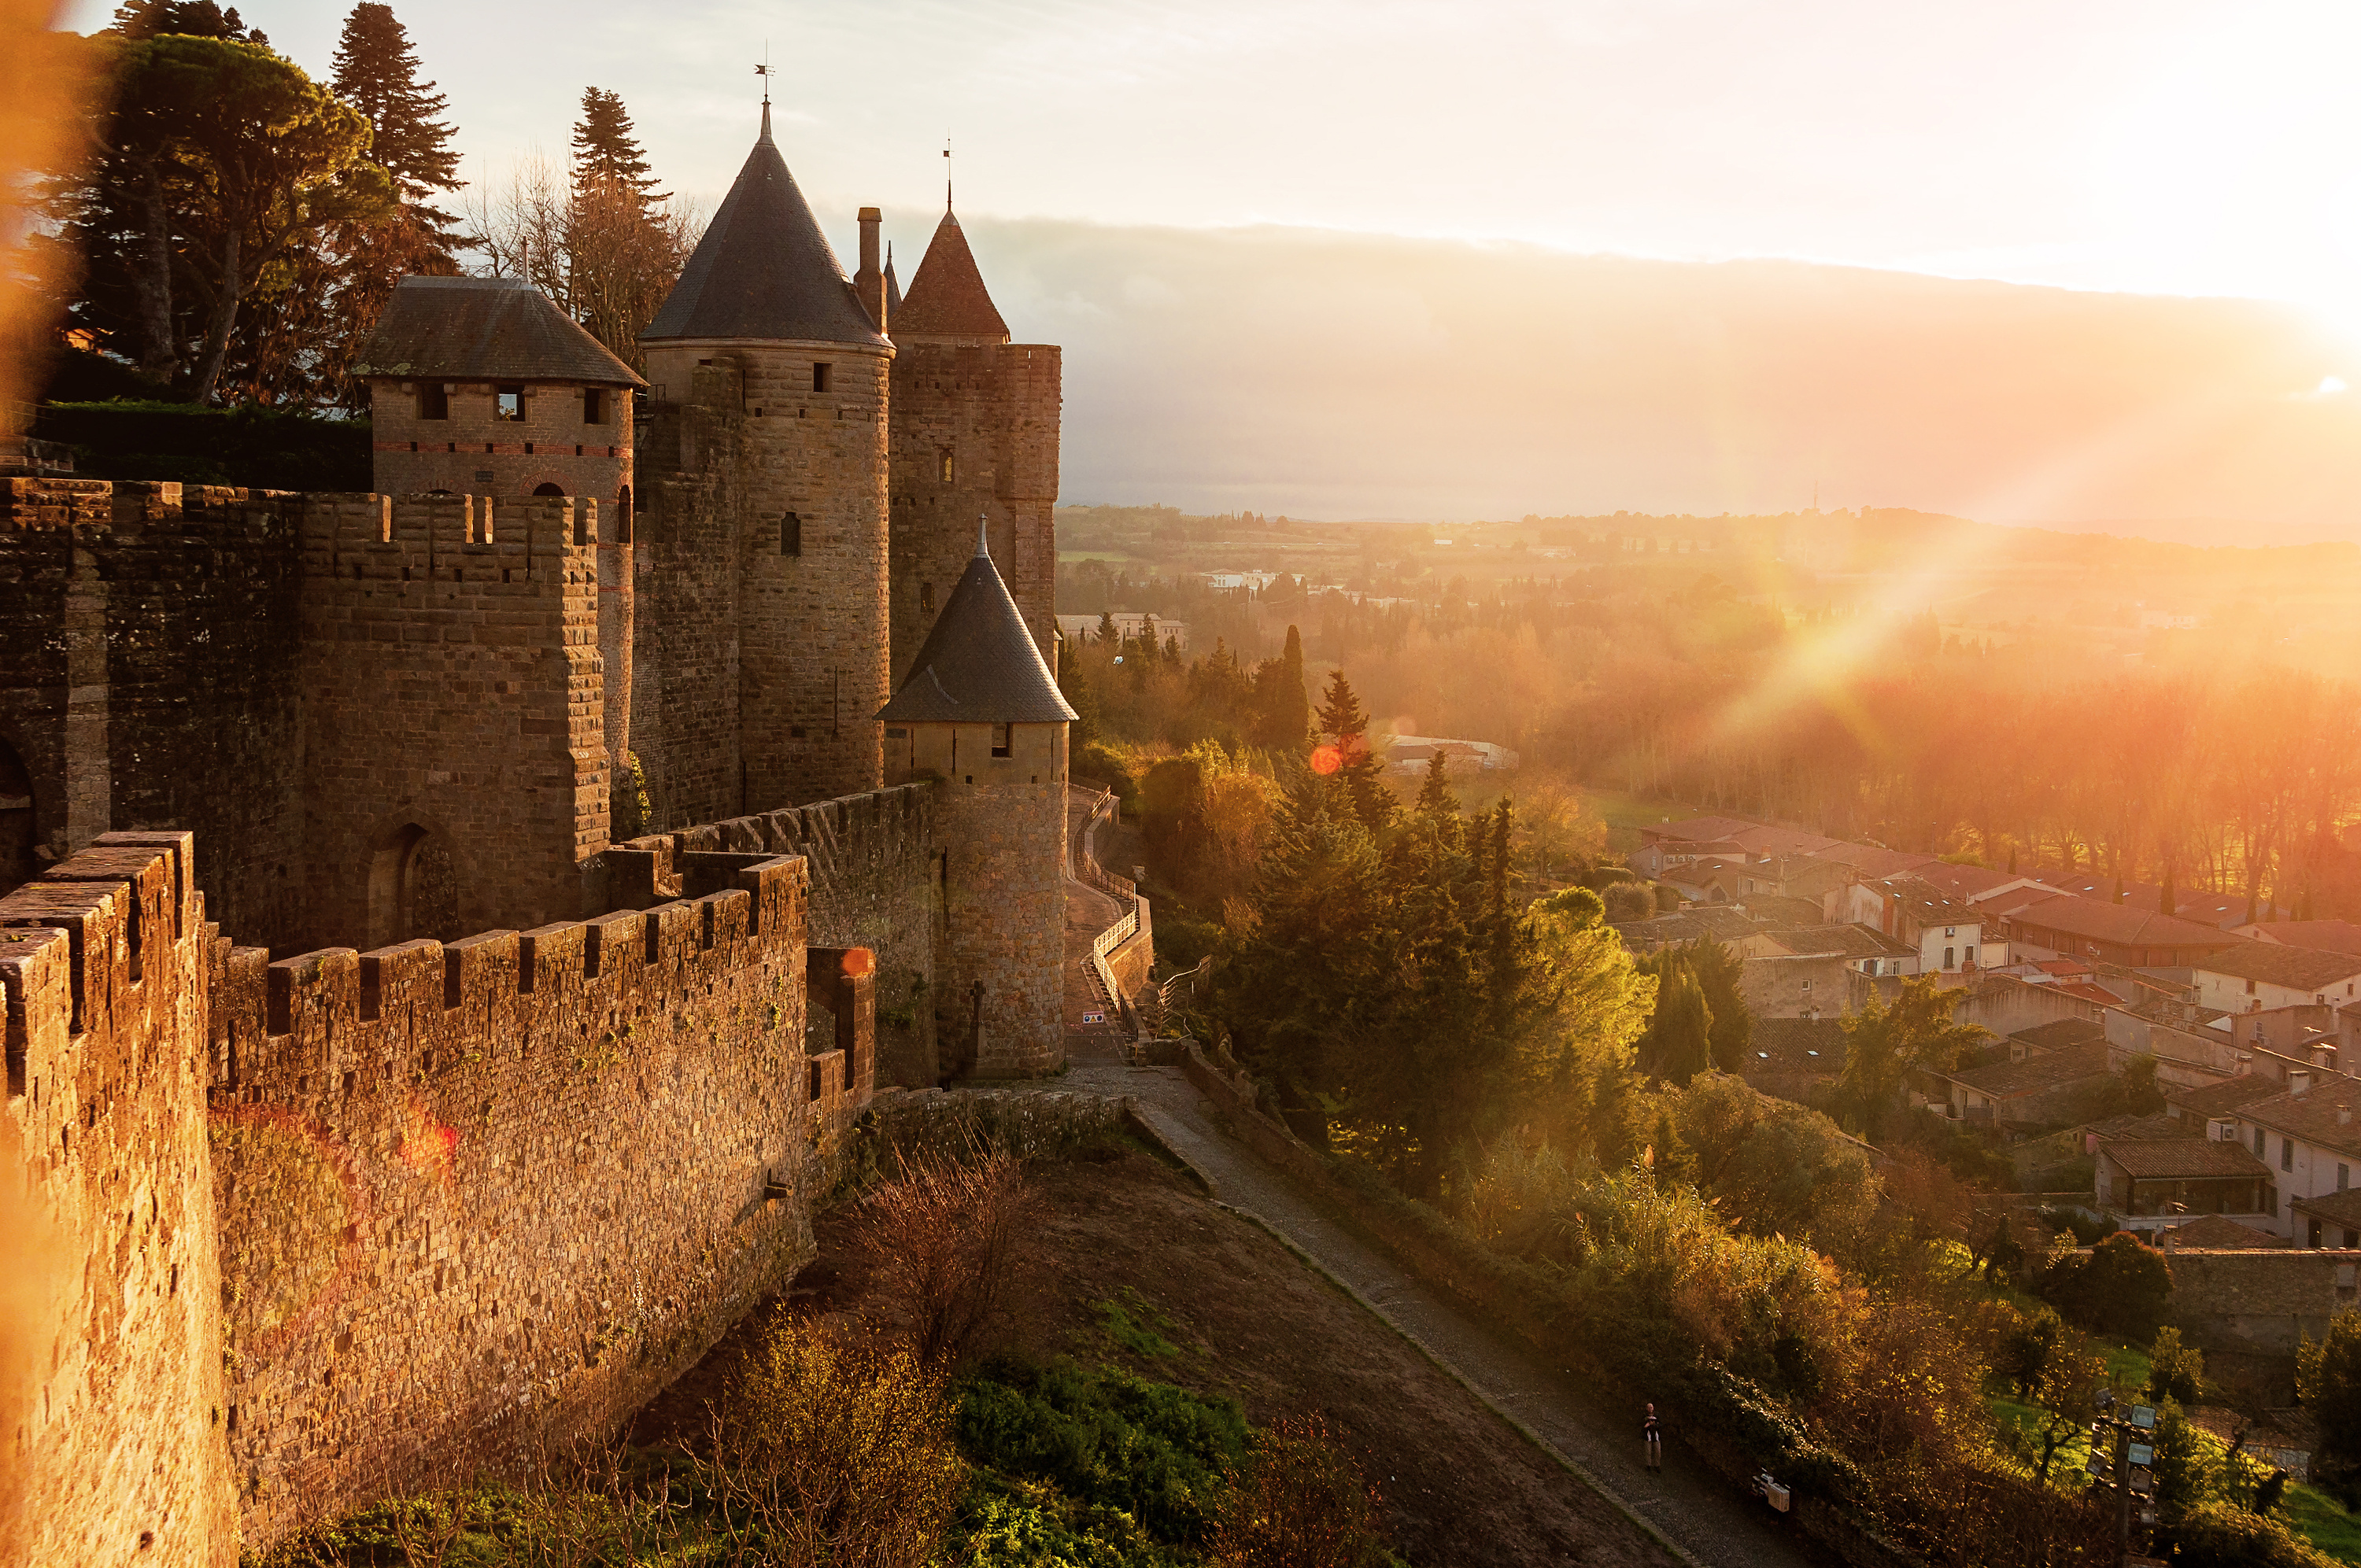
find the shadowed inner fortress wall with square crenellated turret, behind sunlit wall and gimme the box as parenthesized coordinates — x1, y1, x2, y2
(0, 479, 630, 952)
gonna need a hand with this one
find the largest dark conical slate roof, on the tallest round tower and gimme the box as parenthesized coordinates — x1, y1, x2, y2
(640, 104, 885, 347)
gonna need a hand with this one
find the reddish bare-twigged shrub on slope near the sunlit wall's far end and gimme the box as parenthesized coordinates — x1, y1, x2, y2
(857, 1146, 1039, 1367)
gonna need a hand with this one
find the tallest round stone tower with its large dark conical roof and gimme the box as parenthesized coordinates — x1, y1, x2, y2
(640, 104, 892, 825)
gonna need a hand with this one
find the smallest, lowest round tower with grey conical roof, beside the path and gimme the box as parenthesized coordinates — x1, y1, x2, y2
(878, 519, 1074, 1077)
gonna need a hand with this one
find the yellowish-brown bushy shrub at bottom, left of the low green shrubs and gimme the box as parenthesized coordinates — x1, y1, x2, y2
(692, 1315, 966, 1568)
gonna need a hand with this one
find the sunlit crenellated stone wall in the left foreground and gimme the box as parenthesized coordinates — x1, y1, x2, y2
(0, 834, 874, 1568)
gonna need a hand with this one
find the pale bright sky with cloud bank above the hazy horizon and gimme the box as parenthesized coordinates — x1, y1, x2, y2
(66, 0, 2361, 536)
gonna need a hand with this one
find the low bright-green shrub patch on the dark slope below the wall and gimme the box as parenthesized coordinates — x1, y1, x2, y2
(959, 1358, 1247, 1542)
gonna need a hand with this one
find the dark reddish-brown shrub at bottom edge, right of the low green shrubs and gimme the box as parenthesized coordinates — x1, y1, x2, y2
(1206, 1415, 1386, 1568)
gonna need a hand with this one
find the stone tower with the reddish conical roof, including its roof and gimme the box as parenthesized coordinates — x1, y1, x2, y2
(888, 196, 1062, 677)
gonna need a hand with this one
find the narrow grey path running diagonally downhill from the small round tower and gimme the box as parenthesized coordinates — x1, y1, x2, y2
(1055, 1061, 1827, 1568)
